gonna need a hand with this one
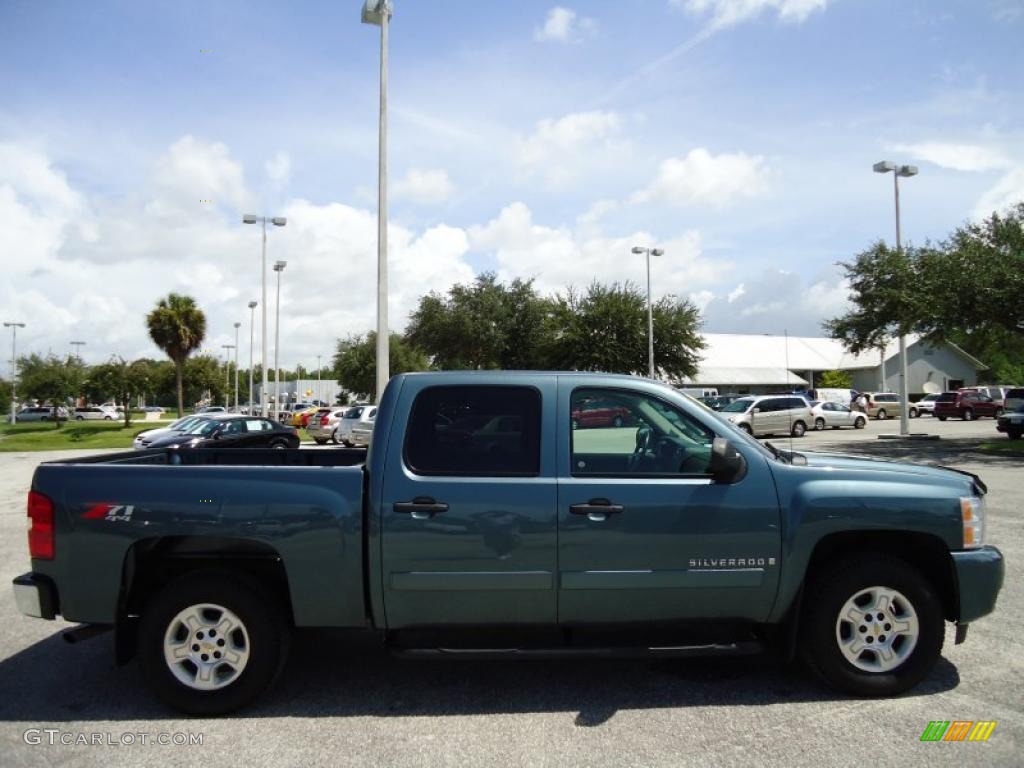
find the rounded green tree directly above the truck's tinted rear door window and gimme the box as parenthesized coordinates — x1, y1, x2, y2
(406, 272, 551, 370)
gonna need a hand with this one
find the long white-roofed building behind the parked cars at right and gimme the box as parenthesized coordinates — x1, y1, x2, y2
(677, 334, 987, 395)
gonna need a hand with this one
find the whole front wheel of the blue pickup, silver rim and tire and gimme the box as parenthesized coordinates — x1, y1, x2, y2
(801, 555, 944, 696)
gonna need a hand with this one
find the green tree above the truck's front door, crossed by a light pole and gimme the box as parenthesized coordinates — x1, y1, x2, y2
(545, 283, 705, 379)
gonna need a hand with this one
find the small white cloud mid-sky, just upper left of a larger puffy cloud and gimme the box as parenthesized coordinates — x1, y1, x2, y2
(519, 111, 631, 185)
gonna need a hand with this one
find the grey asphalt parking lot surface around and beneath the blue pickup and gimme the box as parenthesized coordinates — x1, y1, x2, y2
(0, 418, 1024, 768)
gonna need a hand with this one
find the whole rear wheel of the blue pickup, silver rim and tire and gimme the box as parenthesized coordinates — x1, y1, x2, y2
(138, 570, 288, 715)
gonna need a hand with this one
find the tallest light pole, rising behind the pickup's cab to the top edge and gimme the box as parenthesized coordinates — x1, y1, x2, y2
(361, 0, 391, 402)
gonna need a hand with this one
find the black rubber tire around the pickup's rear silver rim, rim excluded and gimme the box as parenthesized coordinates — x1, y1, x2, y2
(138, 570, 289, 715)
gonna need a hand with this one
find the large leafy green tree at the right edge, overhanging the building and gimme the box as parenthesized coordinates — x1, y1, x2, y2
(824, 203, 1024, 352)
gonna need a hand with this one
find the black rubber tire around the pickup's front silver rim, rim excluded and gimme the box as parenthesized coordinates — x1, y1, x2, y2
(800, 553, 945, 696)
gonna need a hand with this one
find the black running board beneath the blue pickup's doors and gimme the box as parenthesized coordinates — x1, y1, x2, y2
(391, 640, 765, 659)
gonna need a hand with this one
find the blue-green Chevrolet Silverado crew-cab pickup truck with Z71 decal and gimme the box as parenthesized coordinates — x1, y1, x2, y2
(14, 372, 1004, 714)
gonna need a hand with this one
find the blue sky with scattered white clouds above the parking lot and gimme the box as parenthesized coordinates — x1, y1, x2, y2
(0, 0, 1024, 366)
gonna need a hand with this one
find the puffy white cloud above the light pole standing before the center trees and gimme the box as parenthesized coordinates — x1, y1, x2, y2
(630, 147, 768, 206)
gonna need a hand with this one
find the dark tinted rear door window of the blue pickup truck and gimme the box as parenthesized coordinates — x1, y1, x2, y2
(403, 386, 541, 477)
